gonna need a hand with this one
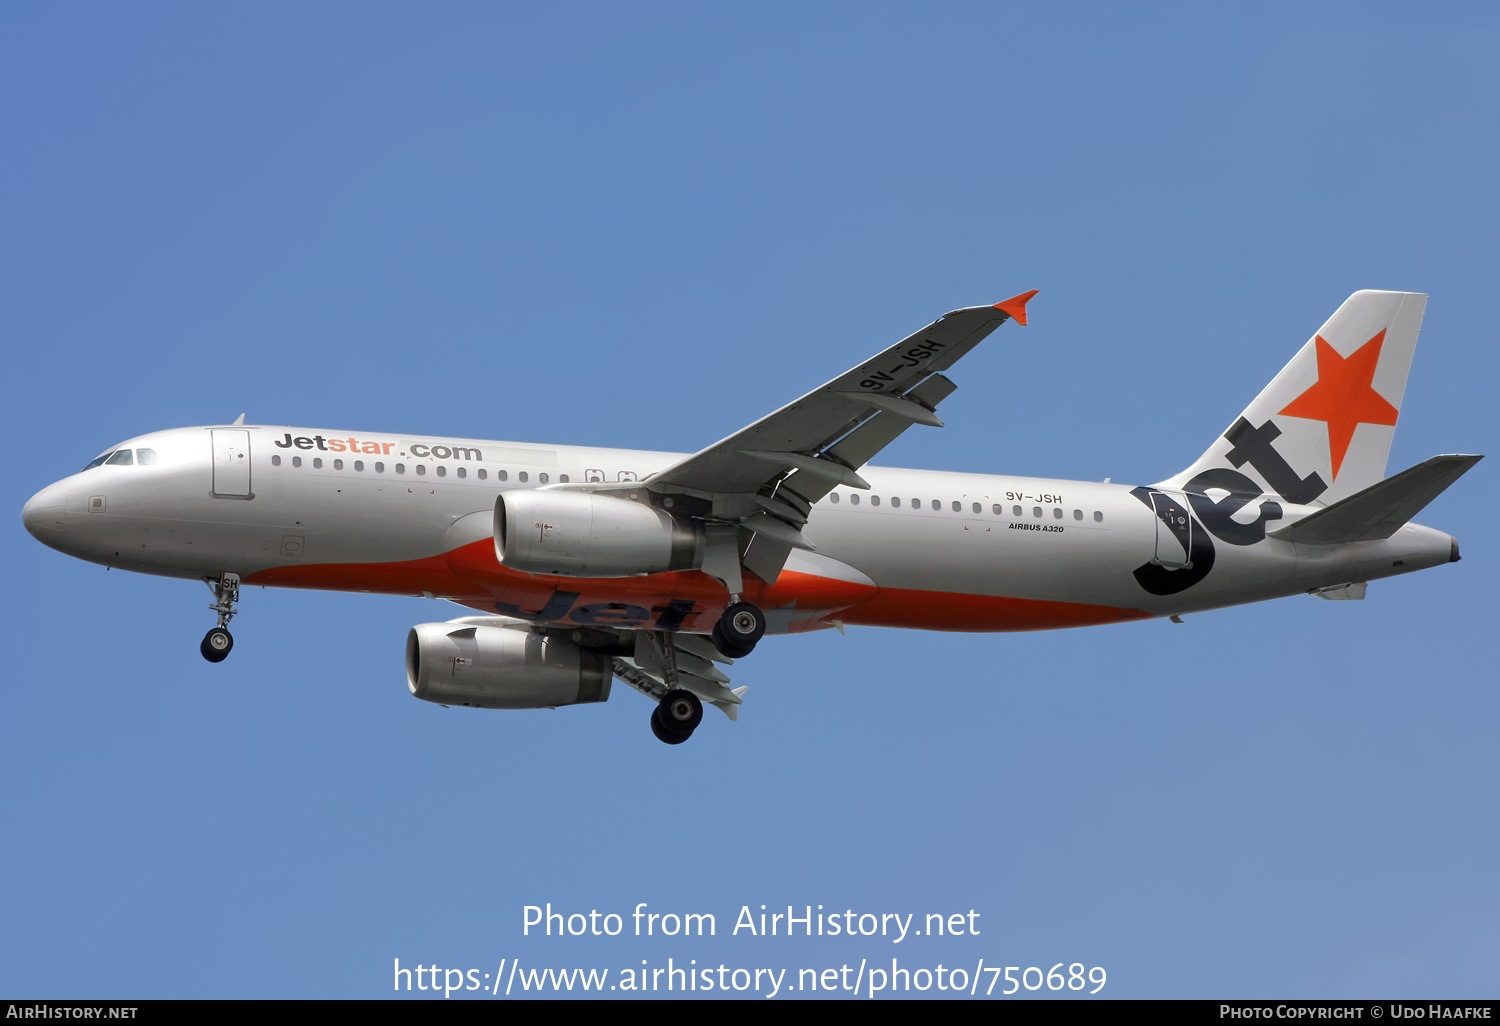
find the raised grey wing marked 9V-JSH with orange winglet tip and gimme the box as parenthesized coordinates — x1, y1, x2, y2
(563, 290, 1037, 594)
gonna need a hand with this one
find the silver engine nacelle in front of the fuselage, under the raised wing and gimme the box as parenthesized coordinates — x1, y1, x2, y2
(495, 489, 704, 578)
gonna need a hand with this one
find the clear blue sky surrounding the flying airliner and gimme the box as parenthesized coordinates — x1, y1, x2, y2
(0, 3, 1500, 999)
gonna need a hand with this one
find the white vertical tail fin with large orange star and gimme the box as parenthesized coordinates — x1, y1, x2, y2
(1158, 291, 1427, 506)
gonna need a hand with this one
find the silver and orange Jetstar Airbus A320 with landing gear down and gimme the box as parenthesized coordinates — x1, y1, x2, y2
(21, 290, 1481, 744)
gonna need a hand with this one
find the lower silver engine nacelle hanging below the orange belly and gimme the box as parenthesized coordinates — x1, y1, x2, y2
(407, 624, 614, 710)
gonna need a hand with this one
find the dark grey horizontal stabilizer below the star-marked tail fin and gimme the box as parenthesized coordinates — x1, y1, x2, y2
(1269, 456, 1484, 545)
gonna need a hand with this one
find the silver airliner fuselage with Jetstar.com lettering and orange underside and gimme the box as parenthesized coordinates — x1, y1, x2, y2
(24, 426, 1457, 633)
